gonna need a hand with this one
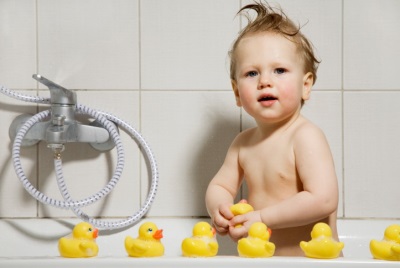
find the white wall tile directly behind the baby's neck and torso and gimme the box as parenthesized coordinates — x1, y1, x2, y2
(242, 91, 344, 216)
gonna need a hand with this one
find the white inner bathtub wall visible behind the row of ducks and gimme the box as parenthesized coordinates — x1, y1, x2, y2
(0, 218, 400, 267)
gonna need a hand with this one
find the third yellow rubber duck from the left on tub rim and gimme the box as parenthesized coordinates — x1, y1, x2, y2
(182, 221, 218, 257)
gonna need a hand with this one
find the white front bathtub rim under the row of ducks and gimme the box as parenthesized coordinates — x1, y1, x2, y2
(0, 256, 400, 268)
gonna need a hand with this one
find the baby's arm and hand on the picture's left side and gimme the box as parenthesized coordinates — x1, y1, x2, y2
(206, 134, 243, 235)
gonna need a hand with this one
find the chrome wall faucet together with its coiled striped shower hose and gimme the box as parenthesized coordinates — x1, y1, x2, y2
(0, 74, 158, 230)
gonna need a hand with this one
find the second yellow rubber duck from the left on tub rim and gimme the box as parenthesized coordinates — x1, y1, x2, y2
(125, 222, 164, 257)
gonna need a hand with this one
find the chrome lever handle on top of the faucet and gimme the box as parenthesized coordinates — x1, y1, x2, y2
(32, 74, 77, 105)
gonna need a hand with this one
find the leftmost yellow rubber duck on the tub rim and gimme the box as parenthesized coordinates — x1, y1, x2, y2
(58, 222, 99, 258)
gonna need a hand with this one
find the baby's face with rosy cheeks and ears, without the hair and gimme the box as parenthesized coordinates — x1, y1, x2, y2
(232, 33, 312, 123)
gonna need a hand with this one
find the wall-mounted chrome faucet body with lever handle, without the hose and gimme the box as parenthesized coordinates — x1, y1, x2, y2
(9, 74, 115, 153)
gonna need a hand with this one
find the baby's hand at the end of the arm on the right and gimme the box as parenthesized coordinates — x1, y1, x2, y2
(229, 210, 262, 241)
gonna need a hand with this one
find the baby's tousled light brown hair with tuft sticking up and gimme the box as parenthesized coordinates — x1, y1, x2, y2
(229, 2, 319, 83)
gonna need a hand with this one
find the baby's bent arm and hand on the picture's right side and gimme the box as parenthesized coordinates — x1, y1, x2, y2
(230, 124, 338, 238)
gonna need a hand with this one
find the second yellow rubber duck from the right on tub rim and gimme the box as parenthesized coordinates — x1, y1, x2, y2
(300, 222, 344, 259)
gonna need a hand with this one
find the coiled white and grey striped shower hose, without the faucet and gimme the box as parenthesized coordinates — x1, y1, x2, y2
(0, 85, 158, 230)
